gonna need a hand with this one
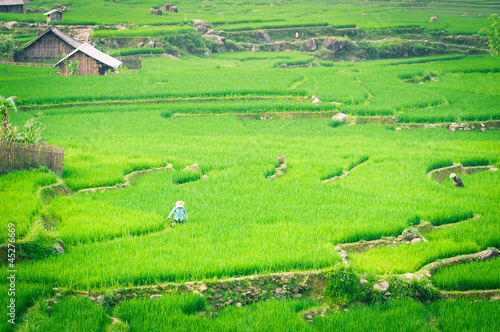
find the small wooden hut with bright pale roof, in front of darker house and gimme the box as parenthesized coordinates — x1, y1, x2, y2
(54, 43, 122, 76)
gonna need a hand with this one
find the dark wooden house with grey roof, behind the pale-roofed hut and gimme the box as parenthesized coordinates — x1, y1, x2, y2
(16, 27, 82, 62)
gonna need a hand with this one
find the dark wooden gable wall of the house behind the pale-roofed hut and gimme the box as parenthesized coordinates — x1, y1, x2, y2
(19, 32, 75, 61)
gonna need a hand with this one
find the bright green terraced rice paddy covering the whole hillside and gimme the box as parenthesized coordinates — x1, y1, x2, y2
(0, 0, 500, 331)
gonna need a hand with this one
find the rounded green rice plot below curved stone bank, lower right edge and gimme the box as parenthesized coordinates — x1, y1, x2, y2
(432, 259, 500, 291)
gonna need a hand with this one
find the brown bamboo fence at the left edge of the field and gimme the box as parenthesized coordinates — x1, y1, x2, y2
(0, 141, 64, 177)
